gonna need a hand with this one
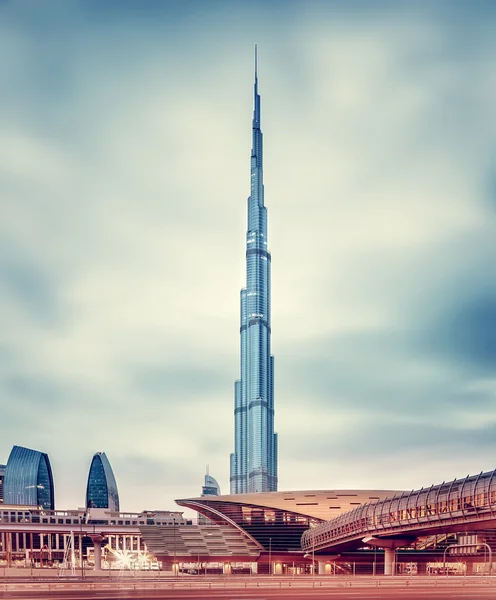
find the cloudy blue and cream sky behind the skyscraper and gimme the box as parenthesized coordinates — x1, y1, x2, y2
(0, 0, 496, 511)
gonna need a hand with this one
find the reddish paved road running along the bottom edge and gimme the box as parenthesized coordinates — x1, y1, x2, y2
(0, 577, 496, 600)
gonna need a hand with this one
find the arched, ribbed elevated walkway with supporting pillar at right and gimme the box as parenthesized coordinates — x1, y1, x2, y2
(301, 470, 496, 573)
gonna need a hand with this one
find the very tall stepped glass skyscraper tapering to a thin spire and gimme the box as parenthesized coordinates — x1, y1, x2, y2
(230, 46, 277, 494)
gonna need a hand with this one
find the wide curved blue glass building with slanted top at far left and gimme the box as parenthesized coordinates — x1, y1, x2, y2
(3, 446, 55, 510)
